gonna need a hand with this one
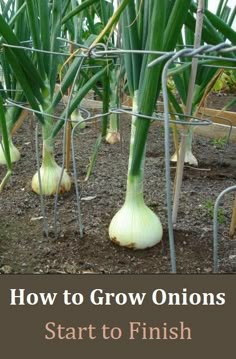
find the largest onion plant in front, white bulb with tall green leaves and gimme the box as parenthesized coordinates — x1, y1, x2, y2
(109, 0, 191, 249)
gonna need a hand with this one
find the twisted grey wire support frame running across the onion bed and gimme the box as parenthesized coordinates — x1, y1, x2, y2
(2, 40, 236, 273)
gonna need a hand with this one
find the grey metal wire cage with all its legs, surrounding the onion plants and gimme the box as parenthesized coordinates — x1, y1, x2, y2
(0, 39, 236, 273)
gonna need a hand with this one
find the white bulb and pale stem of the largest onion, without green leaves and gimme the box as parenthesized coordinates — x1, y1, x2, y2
(109, 94, 163, 249)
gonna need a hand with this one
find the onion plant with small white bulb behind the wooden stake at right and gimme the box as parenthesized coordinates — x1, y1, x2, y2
(171, 1, 236, 166)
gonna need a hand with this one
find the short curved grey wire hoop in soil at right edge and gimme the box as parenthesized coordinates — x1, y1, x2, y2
(213, 185, 236, 273)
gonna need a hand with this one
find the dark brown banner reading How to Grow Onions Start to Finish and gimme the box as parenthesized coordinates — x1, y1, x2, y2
(0, 275, 236, 359)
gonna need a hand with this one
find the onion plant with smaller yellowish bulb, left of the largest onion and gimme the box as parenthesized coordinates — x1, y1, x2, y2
(0, 0, 109, 195)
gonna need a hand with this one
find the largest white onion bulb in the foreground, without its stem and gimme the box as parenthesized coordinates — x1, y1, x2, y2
(109, 188, 163, 249)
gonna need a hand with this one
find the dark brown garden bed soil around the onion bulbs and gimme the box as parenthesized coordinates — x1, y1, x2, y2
(0, 94, 236, 274)
